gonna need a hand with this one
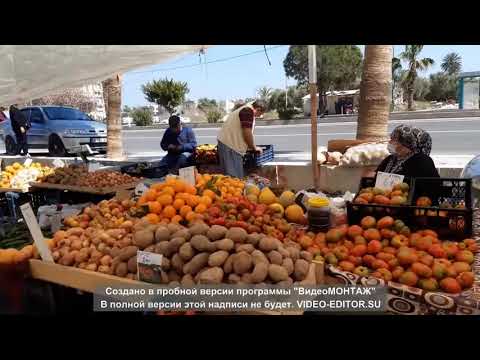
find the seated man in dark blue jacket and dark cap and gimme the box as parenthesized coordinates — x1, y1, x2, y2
(160, 115, 197, 174)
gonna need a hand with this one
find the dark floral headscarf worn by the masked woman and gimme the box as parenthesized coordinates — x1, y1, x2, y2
(385, 125, 432, 173)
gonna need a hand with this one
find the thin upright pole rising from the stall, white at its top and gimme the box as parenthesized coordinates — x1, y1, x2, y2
(308, 45, 320, 190)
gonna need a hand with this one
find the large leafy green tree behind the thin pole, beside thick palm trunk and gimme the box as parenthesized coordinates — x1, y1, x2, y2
(283, 45, 362, 111)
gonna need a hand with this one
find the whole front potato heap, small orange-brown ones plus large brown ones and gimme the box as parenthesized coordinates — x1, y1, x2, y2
(48, 221, 315, 286)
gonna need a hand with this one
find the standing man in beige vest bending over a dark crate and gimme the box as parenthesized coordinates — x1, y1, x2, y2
(217, 100, 266, 178)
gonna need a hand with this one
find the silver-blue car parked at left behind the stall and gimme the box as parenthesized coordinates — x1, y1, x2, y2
(0, 106, 107, 156)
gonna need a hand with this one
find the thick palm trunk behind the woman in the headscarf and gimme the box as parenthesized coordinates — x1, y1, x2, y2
(357, 45, 392, 141)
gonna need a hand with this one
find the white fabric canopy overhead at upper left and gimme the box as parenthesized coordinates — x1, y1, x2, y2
(0, 45, 206, 106)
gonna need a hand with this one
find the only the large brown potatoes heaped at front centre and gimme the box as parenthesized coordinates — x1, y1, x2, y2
(132, 223, 315, 286)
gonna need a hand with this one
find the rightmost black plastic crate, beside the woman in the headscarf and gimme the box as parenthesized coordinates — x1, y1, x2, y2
(410, 178, 473, 239)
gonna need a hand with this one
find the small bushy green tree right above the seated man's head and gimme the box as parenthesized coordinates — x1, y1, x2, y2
(142, 79, 189, 115)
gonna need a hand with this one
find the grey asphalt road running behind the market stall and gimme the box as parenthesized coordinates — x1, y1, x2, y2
(0, 117, 480, 155)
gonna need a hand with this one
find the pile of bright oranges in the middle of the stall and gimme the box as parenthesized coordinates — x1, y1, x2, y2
(137, 177, 217, 224)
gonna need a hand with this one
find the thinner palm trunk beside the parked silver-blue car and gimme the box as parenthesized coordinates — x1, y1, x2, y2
(103, 75, 124, 159)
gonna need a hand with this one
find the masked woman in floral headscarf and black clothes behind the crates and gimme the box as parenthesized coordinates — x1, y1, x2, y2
(377, 125, 440, 178)
